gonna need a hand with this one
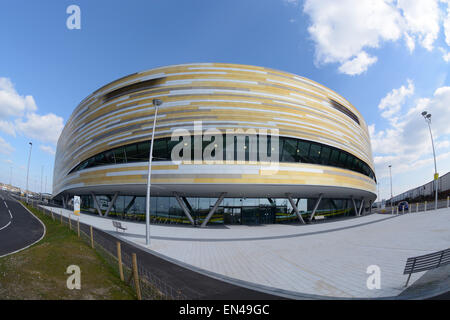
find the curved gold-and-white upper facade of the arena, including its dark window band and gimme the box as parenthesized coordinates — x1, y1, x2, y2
(53, 63, 376, 222)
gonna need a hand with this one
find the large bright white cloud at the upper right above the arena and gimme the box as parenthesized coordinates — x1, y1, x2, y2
(303, 0, 450, 75)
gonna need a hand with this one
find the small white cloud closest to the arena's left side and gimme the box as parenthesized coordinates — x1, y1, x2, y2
(16, 113, 64, 144)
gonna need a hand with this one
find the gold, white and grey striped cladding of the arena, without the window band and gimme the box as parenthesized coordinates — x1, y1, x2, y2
(53, 63, 376, 195)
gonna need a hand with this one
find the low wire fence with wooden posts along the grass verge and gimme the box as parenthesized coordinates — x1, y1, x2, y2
(18, 197, 192, 300)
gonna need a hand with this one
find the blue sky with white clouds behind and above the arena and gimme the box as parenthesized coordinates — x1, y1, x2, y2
(0, 0, 450, 198)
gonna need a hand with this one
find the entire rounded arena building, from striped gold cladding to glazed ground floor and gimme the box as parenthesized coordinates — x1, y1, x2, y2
(53, 63, 376, 226)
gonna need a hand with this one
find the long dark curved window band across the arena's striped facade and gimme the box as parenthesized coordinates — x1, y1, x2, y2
(69, 135, 376, 181)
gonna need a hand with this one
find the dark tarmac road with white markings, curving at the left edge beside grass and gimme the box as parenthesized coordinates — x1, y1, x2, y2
(0, 191, 45, 257)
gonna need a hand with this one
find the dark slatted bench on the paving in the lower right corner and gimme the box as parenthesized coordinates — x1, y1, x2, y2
(403, 248, 450, 287)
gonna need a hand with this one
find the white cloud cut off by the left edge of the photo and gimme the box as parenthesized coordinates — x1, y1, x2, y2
(0, 78, 37, 119)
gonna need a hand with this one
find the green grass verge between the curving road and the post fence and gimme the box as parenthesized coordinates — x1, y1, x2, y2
(0, 202, 136, 300)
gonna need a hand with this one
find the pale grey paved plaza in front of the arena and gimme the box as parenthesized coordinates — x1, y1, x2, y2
(46, 207, 450, 298)
